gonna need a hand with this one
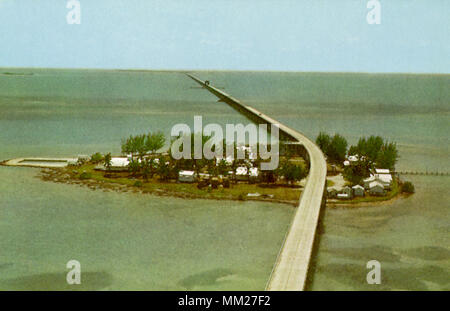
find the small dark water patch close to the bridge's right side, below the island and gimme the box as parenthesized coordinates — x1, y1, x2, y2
(324, 245, 400, 262)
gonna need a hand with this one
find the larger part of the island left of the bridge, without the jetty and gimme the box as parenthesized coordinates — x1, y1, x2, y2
(36, 132, 309, 206)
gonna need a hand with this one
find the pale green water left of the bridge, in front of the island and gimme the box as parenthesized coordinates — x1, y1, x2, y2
(0, 167, 294, 290)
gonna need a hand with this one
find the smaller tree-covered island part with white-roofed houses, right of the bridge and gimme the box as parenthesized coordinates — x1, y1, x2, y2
(316, 132, 414, 207)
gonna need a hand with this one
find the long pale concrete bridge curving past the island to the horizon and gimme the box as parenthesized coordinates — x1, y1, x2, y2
(188, 74, 327, 291)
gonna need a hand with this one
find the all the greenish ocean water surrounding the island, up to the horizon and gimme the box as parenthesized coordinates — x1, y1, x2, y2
(0, 68, 450, 290)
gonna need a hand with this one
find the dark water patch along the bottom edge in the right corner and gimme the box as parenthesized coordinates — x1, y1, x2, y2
(318, 264, 450, 290)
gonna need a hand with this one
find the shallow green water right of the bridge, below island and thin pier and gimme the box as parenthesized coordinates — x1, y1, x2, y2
(310, 176, 450, 291)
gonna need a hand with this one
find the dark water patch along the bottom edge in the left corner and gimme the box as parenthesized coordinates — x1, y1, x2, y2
(0, 272, 113, 291)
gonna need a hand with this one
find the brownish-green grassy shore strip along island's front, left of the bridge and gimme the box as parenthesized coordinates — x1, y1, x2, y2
(57, 164, 301, 204)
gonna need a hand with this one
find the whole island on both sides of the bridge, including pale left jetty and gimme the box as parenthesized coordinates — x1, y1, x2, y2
(2, 132, 414, 207)
